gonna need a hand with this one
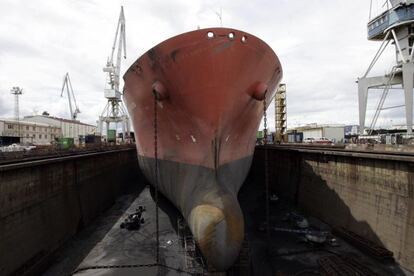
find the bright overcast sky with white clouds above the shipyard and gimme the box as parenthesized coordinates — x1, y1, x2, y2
(0, 0, 405, 128)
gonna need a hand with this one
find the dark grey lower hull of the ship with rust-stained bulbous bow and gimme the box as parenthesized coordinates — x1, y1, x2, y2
(138, 155, 252, 271)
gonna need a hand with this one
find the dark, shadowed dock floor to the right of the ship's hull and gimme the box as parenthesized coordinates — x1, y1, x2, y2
(239, 175, 413, 276)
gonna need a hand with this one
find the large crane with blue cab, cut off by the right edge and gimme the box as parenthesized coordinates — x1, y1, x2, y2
(358, 0, 414, 134)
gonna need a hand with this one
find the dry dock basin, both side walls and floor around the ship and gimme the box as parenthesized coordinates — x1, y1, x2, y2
(0, 146, 414, 275)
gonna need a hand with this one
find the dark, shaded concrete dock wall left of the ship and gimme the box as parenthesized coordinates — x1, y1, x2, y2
(0, 148, 139, 275)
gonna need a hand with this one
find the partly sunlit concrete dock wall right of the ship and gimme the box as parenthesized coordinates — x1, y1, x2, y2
(252, 147, 414, 271)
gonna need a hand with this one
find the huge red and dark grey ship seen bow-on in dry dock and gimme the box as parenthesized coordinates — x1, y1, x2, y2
(123, 28, 283, 271)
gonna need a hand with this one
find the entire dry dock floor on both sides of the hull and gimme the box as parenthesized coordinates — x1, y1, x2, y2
(43, 176, 413, 276)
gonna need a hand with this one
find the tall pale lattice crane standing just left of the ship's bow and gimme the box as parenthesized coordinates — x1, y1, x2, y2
(98, 6, 130, 141)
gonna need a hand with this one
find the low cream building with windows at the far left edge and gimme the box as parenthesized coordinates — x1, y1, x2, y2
(0, 119, 62, 146)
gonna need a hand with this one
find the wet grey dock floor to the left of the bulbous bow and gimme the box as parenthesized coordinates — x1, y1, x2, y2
(43, 182, 209, 276)
